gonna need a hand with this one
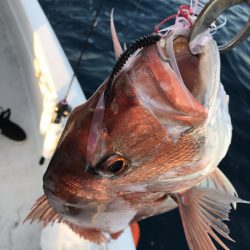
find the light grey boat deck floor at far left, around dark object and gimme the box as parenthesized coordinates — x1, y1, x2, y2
(0, 12, 45, 250)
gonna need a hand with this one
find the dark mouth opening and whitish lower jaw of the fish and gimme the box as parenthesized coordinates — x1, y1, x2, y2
(170, 36, 220, 109)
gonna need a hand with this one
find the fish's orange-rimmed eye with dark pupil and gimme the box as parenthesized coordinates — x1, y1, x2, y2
(95, 155, 129, 178)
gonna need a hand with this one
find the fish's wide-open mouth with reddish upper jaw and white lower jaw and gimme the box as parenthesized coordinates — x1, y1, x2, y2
(133, 36, 220, 141)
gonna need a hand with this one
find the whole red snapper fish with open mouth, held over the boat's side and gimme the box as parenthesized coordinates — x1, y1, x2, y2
(26, 10, 248, 250)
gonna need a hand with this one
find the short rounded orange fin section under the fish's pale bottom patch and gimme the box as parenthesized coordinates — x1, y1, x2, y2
(63, 221, 108, 244)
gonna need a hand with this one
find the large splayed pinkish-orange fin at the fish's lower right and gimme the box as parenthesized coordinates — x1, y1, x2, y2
(175, 187, 247, 250)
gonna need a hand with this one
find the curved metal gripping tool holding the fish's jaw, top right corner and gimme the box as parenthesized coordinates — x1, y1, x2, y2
(188, 0, 250, 53)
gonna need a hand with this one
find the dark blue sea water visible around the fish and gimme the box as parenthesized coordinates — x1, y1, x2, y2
(39, 0, 250, 250)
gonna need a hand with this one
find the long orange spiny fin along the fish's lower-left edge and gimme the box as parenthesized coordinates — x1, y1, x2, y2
(23, 194, 108, 244)
